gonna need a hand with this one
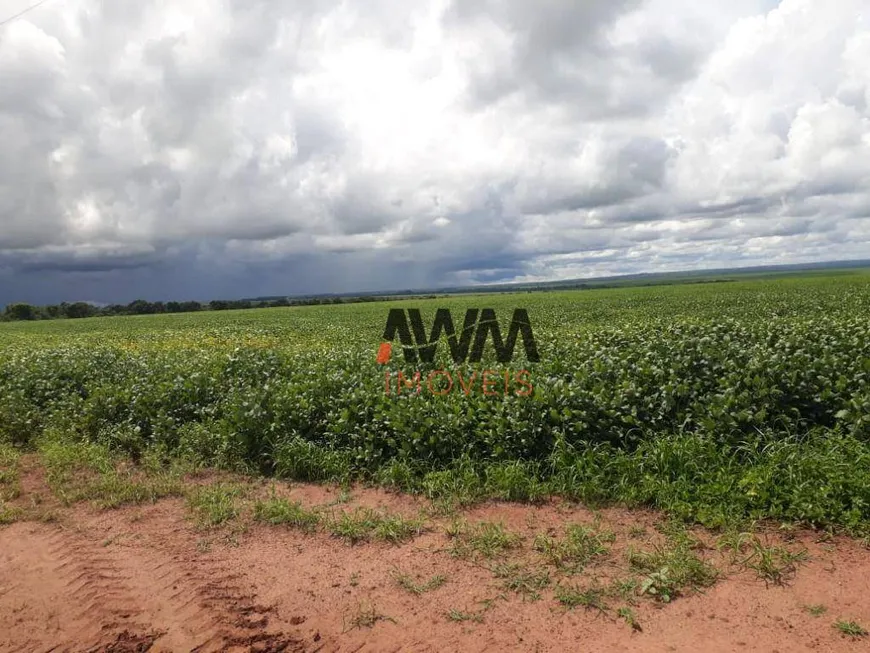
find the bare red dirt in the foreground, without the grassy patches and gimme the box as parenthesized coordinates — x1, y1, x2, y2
(0, 474, 870, 653)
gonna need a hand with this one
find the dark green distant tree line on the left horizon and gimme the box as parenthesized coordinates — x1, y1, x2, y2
(0, 295, 437, 322)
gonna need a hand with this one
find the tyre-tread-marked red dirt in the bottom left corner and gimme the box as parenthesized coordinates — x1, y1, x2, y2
(0, 525, 305, 653)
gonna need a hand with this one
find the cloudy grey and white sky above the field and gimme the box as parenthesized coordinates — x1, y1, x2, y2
(0, 0, 870, 304)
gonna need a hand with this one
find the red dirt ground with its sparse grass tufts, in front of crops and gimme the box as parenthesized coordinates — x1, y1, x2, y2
(0, 461, 870, 653)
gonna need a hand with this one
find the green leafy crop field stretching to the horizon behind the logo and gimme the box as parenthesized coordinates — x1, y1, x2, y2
(0, 272, 870, 530)
